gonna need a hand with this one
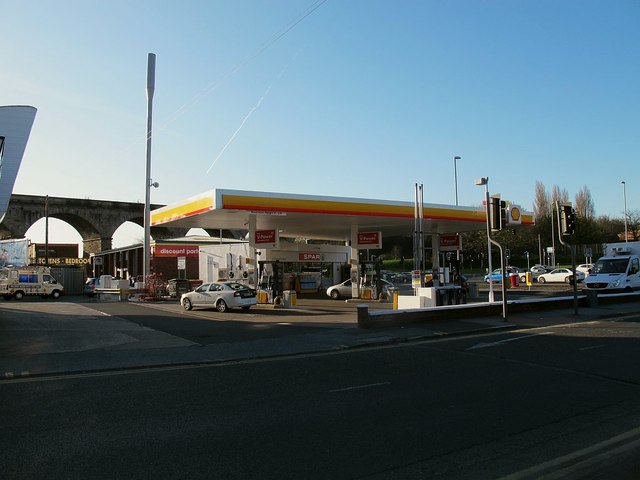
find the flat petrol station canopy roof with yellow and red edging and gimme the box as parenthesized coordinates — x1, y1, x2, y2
(151, 189, 534, 241)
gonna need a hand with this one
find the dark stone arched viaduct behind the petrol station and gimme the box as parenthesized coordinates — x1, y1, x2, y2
(0, 194, 195, 256)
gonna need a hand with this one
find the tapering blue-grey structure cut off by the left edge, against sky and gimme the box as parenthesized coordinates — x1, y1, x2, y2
(0, 105, 36, 223)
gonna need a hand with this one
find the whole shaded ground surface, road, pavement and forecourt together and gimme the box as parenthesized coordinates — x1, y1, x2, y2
(0, 294, 640, 479)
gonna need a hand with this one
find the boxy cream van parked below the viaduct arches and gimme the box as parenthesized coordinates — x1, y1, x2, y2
(0, 267, 64, 300)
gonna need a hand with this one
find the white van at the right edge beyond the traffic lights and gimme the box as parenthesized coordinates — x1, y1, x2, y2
(584, 242, 640, 293)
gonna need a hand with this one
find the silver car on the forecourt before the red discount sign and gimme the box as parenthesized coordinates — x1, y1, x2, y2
(180, 282, 258, 313)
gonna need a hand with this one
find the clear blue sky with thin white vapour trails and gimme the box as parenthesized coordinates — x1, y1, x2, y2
(0, 0, 640, 248)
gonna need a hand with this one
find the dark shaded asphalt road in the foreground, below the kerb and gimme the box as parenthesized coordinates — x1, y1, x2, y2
(0, 315, 640, 479)
